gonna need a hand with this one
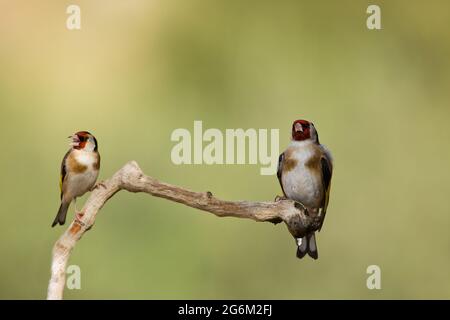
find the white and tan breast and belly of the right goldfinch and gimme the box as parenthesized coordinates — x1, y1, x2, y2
(281, 141, 324, 208)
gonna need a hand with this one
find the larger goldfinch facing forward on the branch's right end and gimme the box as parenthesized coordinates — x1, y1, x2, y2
(277, 120, 333, 259)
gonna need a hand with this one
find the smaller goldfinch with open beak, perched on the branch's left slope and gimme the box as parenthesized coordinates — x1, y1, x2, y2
(52, 131, 100, 227)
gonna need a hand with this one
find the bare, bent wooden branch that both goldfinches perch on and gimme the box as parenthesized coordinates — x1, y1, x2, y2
(47, 161, 320, 299)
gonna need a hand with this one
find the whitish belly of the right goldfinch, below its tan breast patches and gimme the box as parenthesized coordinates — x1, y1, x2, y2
(282, 165, 323, 208)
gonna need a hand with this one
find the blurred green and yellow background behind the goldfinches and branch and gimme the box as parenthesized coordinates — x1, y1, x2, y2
(0, 0, 450, 299)
